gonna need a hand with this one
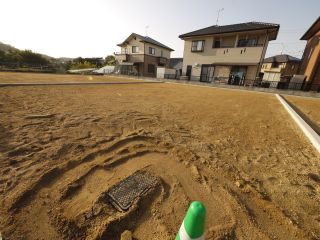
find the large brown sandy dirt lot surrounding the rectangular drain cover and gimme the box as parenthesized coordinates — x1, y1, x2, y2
(0, 76, 320, 240)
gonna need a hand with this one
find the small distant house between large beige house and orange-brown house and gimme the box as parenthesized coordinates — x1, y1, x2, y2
(261, 54, 300, 82)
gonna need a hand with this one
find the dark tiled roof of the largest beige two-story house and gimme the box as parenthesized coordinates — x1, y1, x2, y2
(179, 22, 280, 39)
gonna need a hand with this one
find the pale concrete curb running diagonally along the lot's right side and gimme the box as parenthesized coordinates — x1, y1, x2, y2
(275, 94, 320, 153)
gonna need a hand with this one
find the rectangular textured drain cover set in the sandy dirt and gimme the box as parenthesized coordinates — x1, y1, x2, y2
(106, 171, 158, 211)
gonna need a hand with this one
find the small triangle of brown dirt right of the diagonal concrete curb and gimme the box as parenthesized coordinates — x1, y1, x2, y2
(285, 96, 320, 129)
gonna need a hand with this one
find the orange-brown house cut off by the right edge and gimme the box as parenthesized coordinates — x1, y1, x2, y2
(299, 17, 320, 91)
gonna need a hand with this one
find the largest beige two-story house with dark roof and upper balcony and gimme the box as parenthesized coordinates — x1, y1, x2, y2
(179, 22, 280, 85)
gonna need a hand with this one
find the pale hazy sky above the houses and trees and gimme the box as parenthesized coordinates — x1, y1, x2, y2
(0, 0, 320, 57)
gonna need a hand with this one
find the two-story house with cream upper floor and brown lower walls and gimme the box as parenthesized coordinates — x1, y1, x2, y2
(115, 33, 174, 77)
